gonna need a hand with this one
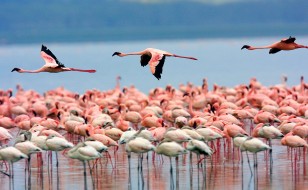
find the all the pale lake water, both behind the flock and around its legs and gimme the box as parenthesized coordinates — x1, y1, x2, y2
(0, 37, 308, 190)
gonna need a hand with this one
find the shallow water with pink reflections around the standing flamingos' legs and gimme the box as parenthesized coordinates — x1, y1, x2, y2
(0, 122, 308, 190)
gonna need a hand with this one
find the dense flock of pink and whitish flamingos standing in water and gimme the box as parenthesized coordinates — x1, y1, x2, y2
(0, 77, 308, 183)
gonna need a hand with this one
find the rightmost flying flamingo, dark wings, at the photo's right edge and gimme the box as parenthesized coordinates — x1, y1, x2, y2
(241, 36, 308, 54)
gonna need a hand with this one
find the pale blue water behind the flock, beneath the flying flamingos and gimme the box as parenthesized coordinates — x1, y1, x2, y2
(0, 36, 308, 93)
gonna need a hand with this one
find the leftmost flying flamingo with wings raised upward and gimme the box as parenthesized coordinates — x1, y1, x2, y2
(12, 45, 96, 73)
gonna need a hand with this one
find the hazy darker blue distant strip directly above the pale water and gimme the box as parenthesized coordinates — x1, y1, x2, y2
(0, 24, 308, 45)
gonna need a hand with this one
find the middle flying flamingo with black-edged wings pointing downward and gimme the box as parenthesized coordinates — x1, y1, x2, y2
(112, 48, 197, 80)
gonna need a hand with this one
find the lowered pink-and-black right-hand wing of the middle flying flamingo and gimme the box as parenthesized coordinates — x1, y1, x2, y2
(149, 53, 166, 80)
